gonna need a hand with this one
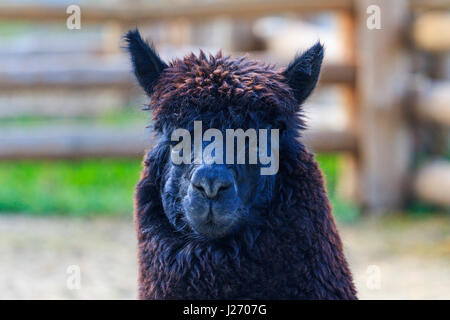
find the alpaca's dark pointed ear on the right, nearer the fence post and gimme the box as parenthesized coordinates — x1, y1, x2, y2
(282, 42, 324, 104)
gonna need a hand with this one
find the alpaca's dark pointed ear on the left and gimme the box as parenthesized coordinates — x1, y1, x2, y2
(125, 29, 167, 96)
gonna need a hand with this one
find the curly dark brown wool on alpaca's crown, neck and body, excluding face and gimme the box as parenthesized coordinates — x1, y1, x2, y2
(135, 53, 356, 299)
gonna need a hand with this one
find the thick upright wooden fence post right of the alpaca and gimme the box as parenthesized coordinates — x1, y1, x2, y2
(355, 0, 412, 212)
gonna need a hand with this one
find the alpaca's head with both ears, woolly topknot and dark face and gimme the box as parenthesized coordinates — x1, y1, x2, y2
(126, 30, 323, 239)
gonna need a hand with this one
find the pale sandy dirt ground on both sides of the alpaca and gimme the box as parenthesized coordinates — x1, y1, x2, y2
(0, 215, 450, 299)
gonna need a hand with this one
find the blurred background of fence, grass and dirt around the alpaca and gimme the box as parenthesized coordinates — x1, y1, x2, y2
(0, 0, 450, 299)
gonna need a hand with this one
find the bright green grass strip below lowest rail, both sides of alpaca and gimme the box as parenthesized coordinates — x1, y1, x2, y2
(0, 155, 358, 221)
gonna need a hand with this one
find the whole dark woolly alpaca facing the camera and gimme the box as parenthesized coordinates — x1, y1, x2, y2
(126, 30, 356, 299)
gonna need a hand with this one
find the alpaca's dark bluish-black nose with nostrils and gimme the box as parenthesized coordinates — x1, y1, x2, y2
(191, 165, 234, 199)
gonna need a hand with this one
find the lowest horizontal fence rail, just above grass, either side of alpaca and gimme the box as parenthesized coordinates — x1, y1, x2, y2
(0, 124, 356, 159)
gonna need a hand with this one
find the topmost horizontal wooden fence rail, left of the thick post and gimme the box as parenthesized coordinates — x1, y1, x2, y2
(0, 0, 353, 25)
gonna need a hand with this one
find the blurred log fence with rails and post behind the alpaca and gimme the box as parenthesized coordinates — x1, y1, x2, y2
(0, 0, 450, 210)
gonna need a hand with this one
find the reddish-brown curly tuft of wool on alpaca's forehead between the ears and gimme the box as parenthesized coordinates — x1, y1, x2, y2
(150, 51, 299, 129)
